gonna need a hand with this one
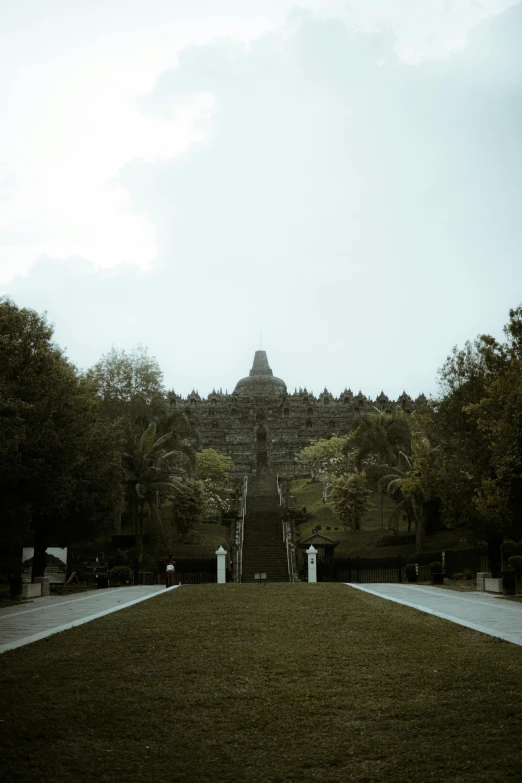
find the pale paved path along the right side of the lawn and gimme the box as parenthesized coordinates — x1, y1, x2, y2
(348, 583, 522, 645)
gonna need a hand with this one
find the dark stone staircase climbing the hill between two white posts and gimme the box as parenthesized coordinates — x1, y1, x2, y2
(241, 470, 288, 582)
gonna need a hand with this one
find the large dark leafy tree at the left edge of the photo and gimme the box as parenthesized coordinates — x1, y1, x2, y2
(0, 299, 121, 578)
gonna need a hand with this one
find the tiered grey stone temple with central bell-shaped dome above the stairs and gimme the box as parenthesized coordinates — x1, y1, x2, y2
(169, 351, 415, 478)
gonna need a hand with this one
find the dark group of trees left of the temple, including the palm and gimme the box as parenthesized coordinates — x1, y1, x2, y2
(0, 298, 197, 579)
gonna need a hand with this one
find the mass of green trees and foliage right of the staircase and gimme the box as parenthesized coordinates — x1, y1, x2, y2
(299, 306, 522, 572)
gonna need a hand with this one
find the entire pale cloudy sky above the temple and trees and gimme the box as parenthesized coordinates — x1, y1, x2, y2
(0, 0, 522, 399)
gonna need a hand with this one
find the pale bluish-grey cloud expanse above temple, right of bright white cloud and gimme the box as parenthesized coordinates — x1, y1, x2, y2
(5, 3, 522, 396)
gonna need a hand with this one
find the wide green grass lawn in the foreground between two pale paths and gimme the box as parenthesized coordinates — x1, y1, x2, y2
(0, 584, 522, 783)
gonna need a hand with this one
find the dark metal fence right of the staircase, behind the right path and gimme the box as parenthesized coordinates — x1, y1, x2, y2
(312, 548, 489, 583)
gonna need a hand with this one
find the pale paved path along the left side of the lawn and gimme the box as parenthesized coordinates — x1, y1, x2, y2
(0, 585, 177, 654)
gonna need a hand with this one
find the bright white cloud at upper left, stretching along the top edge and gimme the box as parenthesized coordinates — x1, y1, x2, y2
(0, 0, 513, 285)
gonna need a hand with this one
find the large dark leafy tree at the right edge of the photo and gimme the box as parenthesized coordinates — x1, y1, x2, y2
(406, 307, 522, 574)
